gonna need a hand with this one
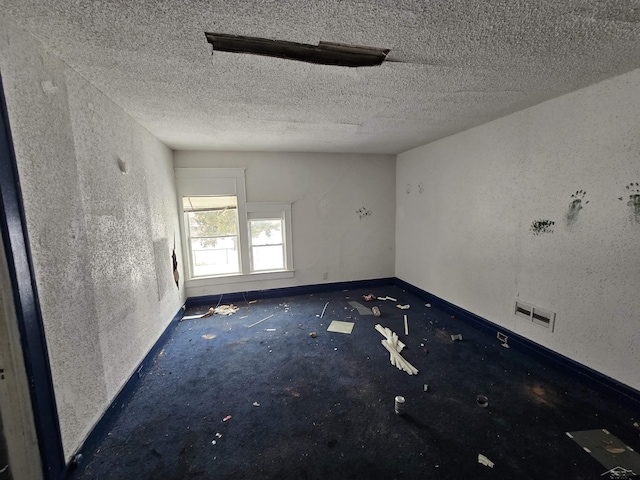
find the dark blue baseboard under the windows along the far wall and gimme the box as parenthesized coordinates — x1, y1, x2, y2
(185, 277, 396, 308)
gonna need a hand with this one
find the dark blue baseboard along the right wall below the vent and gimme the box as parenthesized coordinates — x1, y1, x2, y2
(395, 278, 640, 408)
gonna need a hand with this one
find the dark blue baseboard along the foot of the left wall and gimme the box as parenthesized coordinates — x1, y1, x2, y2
(61, 308, 184, 479)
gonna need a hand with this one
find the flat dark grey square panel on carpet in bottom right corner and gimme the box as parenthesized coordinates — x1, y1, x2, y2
(566, 428, 640, 478)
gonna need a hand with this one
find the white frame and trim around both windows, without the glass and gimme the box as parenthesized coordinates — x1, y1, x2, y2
(174, 168, 294, 287)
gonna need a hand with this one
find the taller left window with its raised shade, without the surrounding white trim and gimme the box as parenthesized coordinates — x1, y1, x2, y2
(182, 196, 240, 277)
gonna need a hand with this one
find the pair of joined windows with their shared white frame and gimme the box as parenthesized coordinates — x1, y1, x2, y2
(175, 168, 293, 286)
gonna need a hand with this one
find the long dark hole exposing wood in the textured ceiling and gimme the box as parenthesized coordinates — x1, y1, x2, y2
(205, 32, 390, 67)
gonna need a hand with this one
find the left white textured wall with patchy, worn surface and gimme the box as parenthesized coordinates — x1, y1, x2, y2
(0, 17, 184, 458)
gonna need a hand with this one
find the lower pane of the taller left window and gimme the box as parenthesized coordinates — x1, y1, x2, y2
(191, 236, 240, 277)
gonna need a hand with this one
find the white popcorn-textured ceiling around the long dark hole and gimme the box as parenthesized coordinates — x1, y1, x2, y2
(0, 0, 640, 153)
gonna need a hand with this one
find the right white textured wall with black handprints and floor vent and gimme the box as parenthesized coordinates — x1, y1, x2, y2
(396, 70, 640, 389)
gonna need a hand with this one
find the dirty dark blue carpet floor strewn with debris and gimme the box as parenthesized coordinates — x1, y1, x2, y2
(72, 286, 640, 480)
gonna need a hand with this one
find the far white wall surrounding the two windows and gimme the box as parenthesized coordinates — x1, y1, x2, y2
(174, 151, 395, 296)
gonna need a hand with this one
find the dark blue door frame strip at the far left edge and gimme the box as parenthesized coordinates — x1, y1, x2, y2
(0, 72, 65, 479)
